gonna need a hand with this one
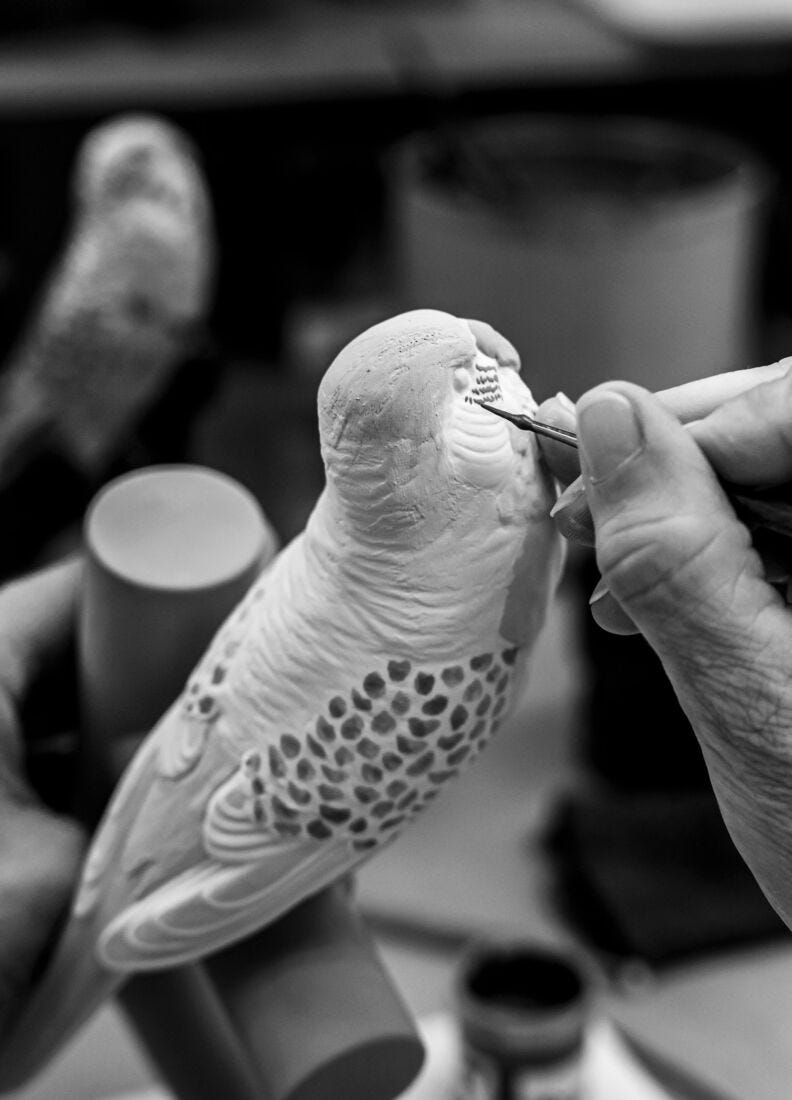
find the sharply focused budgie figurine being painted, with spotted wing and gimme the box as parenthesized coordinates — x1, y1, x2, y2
(0, 310, 562, 1088)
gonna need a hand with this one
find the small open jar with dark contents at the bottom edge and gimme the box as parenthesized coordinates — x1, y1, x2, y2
(455, 942, 589, 1100)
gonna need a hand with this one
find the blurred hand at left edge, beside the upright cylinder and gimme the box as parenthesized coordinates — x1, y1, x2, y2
(0, 561, 85, 1044)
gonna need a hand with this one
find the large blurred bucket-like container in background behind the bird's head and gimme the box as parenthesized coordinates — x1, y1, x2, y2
(393, 117, 769, 398)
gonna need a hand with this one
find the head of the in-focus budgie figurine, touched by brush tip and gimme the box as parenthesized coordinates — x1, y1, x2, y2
(319, 309, 550, 545)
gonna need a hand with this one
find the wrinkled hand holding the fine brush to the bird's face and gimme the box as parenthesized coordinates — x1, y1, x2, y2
(539, 361, 792, 927)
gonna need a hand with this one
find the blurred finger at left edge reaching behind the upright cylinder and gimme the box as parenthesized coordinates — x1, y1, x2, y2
(0, 558, 83, 699)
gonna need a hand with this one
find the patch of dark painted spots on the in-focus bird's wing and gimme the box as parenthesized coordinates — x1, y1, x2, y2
(198, 649, 517, 862)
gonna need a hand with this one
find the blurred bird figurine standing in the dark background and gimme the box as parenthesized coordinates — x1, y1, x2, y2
(0, 116, 213, 486)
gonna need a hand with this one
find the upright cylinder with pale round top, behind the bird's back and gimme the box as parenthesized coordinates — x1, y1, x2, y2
(78, 465, 276, 757)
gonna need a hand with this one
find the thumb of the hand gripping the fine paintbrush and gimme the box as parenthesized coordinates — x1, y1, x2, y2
(578, 383, 782, 680)
